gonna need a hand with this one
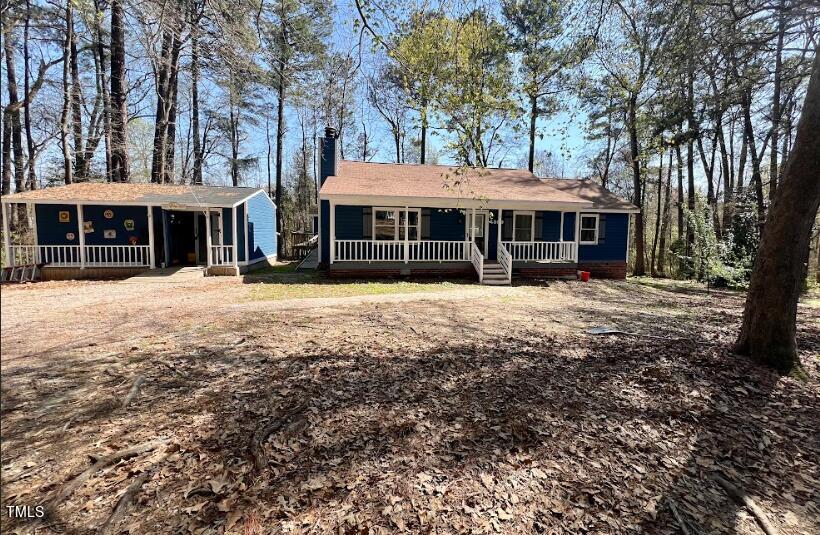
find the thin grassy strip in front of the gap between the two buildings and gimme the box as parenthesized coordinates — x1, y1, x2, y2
(251, 277, 477, 301)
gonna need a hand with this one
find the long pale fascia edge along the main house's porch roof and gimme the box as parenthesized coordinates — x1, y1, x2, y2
(319, 194, 593, 212)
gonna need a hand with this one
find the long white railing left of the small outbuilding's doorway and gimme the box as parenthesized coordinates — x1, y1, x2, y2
(9, 245, 151, 267)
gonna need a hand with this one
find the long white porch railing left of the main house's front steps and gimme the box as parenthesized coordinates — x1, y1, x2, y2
(333, 240, 470, 262)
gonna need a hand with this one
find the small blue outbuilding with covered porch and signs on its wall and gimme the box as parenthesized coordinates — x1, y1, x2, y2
(2, 182, 277, 279)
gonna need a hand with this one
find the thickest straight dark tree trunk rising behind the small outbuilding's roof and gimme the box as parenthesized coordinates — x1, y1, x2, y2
(111, 0, 128, 182)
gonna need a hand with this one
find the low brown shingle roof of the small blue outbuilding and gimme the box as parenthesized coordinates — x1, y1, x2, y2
(2, 182, 263, 207)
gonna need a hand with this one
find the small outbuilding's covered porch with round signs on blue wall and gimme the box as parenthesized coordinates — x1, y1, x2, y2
(3, 203, 259, 280)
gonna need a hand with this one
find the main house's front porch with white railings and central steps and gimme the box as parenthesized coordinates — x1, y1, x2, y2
(325, 204, 582, 284)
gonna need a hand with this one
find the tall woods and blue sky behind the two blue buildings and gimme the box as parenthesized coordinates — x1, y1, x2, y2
(2, 0, 820, 276)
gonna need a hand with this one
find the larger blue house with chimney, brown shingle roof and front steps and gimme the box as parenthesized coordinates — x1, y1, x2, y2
(319, 128, 639, 284)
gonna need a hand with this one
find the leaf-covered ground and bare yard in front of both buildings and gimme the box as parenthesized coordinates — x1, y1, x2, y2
(0, 279, 820, 534)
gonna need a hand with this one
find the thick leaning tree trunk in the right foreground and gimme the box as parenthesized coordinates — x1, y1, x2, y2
(735, 52, 820, 373)
